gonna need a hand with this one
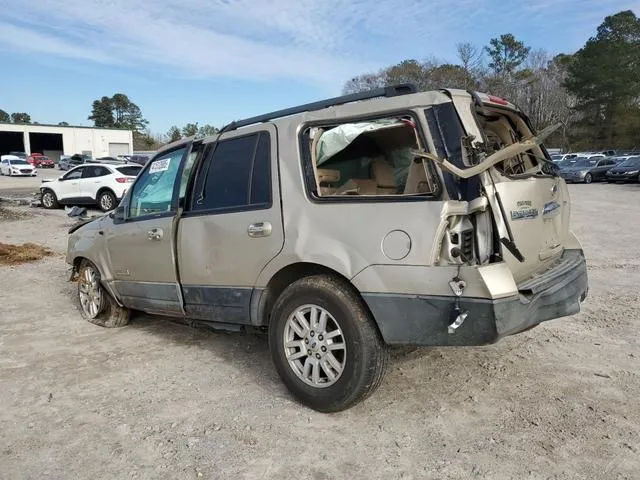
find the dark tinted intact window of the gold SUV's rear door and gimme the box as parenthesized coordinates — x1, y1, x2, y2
(192, 132, 271, 211)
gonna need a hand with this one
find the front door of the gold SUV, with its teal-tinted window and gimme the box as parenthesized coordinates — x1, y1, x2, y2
(106, 145, 188, 315)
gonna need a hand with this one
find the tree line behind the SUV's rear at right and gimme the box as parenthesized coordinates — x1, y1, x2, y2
(343, 10, 640, 150)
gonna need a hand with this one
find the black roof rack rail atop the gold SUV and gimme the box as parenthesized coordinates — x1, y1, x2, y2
(219, 83, 418, 133)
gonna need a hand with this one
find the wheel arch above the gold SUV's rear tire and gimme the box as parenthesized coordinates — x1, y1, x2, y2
(251, 262, 380, 331)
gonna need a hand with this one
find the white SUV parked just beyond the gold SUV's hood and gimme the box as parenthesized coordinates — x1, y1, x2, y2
(40, 163, 142, 212)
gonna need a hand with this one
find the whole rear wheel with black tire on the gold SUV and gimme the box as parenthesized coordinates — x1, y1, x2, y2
(269, 275, 389, 412)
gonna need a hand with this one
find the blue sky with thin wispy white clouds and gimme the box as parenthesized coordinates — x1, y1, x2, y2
(0, 0, 640, 133)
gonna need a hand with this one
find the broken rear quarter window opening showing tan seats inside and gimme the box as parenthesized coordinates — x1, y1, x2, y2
(303, 117, 439, 198)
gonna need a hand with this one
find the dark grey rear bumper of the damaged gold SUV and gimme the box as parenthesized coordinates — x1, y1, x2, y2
(363, 250, 588, 346)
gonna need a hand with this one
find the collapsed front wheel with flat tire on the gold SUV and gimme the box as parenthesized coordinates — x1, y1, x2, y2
(78, 260, 131, 328)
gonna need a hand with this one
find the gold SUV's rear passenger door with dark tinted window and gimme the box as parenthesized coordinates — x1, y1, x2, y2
(177, 125, 284, 323)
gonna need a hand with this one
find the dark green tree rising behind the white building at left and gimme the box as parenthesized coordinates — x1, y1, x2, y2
(88, 93, 149, 132)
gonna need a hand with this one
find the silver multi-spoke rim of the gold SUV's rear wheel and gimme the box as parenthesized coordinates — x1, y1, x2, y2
(283, 305, 347, 388)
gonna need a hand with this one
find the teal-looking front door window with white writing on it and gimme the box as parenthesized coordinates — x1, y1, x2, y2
(127, 147, 185, 218)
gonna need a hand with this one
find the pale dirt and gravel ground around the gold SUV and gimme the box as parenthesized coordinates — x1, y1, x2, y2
(0, 179, 640, 480)
